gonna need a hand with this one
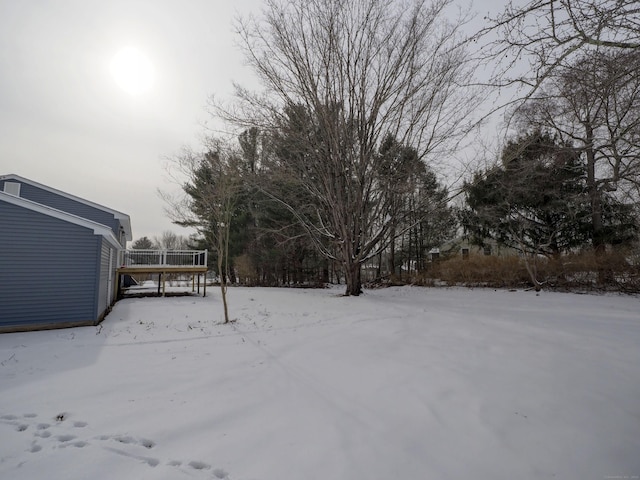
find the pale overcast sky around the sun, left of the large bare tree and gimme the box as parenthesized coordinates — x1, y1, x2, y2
(0, 0, 508, 244)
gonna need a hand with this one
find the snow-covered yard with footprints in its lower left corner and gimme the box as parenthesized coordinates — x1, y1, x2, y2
(0, 287, 640, 480)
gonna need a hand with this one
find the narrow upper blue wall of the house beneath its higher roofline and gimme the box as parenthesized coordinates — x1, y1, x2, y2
(0, 180, 120, 240)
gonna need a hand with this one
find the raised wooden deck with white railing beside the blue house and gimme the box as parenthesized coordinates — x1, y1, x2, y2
(116, 250, 208, 297)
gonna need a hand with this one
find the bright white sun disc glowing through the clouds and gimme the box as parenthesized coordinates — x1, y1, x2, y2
(109, 47, 155, 96)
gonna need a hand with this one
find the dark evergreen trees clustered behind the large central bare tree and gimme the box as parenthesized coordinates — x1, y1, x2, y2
(167, 130, 455, 285)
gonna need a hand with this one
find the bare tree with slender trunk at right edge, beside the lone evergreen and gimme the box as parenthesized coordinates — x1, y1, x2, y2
(516, 50, 640, 252)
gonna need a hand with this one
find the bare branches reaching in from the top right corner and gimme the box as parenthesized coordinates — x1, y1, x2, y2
(474, 0, 640, 105)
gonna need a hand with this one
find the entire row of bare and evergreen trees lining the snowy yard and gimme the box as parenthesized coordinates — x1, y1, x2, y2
(160, 0, 640, 295)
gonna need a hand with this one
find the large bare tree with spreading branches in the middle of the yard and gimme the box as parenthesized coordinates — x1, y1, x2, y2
(214, 0, 477, 295)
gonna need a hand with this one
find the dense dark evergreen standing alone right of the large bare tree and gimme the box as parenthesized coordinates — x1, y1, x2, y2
(462, 131, 589, 255)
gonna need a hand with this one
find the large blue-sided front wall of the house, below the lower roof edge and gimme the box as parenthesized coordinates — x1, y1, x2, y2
(0, 202, 102, 331)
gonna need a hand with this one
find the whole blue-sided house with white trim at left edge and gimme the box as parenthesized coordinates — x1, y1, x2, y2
(0, 175, 131, 332)
